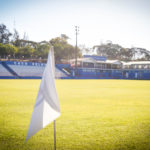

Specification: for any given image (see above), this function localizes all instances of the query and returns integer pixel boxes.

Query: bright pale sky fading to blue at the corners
[0,0,150,50]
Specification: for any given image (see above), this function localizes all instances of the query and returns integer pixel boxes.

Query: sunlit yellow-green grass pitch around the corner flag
[0,80,150,150]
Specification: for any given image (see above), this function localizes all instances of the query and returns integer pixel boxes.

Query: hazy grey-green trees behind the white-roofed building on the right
[93,42,150,61]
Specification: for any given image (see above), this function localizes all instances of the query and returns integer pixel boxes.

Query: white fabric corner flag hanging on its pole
[26,47,60,141]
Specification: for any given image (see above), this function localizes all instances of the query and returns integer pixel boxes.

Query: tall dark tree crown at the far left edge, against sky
[0,24,12,44]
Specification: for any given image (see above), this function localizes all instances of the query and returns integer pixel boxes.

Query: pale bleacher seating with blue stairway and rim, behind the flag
[0,61,67,79]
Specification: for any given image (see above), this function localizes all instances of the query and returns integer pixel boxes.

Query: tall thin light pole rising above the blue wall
[75,26,79,76]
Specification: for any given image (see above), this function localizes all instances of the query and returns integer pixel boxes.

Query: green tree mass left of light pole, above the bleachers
[0,24,81,63]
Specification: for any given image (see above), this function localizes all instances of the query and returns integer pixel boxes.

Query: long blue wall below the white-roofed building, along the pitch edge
[72,68,150,80]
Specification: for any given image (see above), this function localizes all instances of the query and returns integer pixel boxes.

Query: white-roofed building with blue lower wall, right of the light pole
[68,55,150,80]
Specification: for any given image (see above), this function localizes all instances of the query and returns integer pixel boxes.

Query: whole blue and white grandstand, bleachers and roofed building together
[0,55,150,80]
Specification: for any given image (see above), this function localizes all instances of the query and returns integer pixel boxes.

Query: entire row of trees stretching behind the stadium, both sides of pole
[0,24,150,63]
